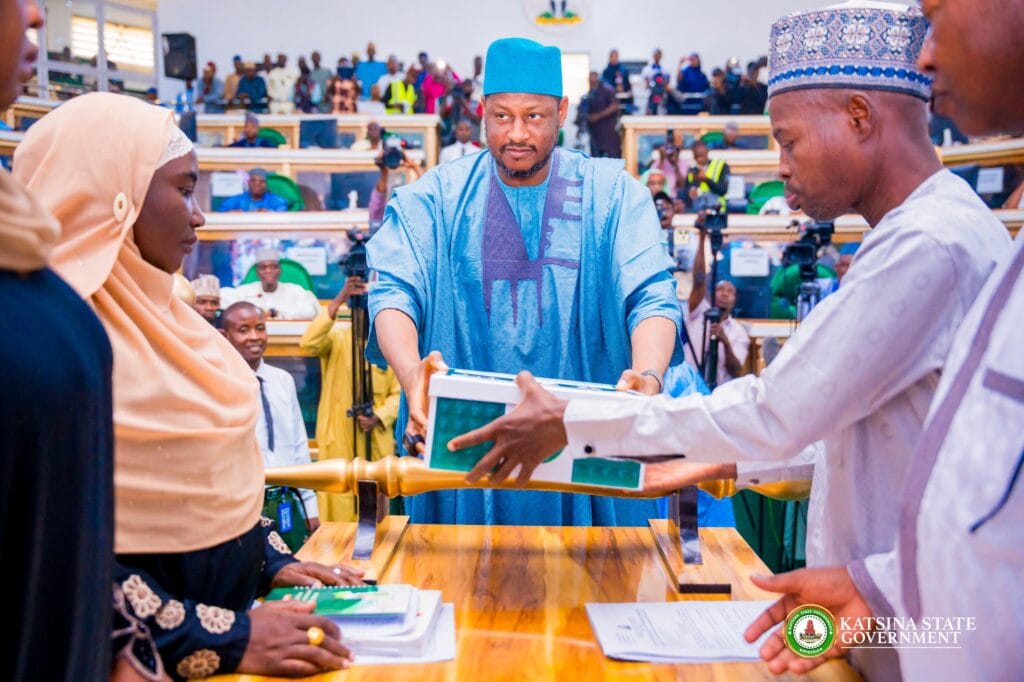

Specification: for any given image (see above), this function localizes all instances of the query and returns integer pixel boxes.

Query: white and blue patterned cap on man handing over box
[768,0,932,100]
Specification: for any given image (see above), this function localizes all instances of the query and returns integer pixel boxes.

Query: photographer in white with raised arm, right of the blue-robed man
[684,215,751,378]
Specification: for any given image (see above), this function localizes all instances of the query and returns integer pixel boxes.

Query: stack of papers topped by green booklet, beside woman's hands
[266,585,455,665]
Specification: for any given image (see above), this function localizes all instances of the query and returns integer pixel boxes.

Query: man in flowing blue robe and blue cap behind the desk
[367,39,681,525]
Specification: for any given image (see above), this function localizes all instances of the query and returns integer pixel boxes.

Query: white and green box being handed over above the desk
[424,370,643,491]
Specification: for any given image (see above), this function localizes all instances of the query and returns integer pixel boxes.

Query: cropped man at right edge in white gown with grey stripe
[746,0,1024,681]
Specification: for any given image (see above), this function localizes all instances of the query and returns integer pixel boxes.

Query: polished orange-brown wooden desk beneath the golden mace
[216,523,859,682]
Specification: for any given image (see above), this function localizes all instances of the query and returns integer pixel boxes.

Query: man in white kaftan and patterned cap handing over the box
[451,2,1010,673]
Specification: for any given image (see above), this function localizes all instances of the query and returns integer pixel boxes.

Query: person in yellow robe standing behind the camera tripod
[299,276,401,521]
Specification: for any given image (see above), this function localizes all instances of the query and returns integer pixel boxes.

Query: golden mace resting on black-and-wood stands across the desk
[266,456,731,594]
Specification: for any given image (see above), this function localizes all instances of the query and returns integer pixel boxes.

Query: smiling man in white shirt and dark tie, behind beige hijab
[220,302,319,543]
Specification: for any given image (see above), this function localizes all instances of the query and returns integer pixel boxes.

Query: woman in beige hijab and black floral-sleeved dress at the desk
[14,93,358,678]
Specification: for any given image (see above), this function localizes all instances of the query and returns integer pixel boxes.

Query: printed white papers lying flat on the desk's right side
[587,601,774,663]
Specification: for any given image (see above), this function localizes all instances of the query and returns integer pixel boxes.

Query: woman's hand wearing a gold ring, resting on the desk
[237,601,352,677]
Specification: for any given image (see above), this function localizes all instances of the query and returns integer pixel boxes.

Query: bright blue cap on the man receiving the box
[483,38,562,98]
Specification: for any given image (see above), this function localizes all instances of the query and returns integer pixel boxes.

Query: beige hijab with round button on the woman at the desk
[14,93,263,553]
